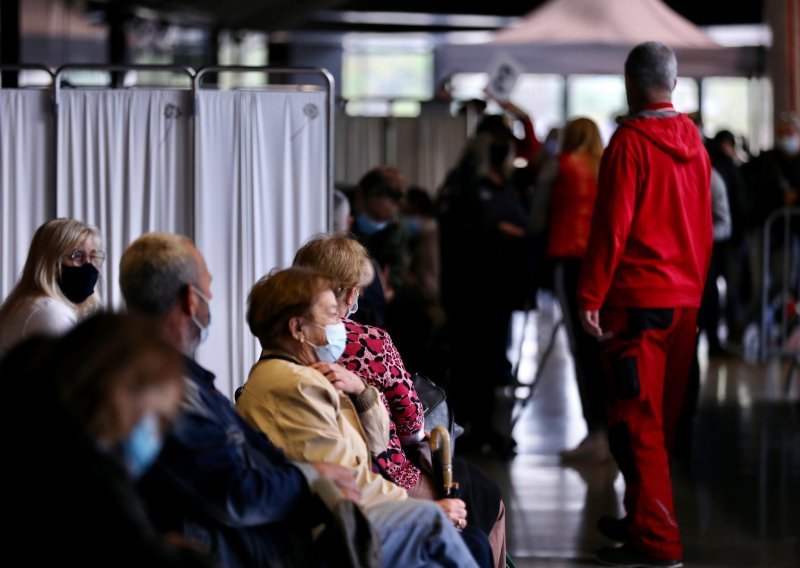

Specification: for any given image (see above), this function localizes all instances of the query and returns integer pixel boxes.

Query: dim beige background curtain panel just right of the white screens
[334,110,386,189]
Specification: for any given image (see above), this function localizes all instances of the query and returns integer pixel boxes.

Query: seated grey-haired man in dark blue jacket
[120,233,376,568]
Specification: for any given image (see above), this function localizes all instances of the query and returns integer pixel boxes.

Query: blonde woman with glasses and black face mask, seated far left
[0,219,105,356]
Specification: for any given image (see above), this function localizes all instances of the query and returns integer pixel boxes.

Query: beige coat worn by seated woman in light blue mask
[236,359,406,509]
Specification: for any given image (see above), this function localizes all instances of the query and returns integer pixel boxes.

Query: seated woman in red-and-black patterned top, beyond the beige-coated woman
[294,234,506,567]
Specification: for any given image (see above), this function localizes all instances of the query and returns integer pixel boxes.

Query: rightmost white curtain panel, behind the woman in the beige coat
[195,91,331,399]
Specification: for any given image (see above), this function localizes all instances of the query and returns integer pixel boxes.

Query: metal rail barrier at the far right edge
[759,207,800,362]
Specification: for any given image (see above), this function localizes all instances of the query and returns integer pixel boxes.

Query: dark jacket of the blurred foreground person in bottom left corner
[10,392,215,568]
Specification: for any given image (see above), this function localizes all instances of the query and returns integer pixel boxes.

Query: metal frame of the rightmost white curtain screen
[193,65,335,233]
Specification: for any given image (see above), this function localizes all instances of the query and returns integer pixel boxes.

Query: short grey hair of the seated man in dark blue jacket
[119,233,200,316]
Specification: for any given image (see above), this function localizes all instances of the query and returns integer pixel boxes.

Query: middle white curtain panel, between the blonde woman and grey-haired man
[56,89,192,309]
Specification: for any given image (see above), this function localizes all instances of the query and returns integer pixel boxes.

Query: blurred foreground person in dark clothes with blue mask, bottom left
[0,313,215,568]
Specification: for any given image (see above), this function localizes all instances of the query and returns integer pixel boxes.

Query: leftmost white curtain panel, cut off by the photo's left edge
[0,89,54,303]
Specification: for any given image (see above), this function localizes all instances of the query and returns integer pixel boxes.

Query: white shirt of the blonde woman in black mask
[0,296,78,357]
